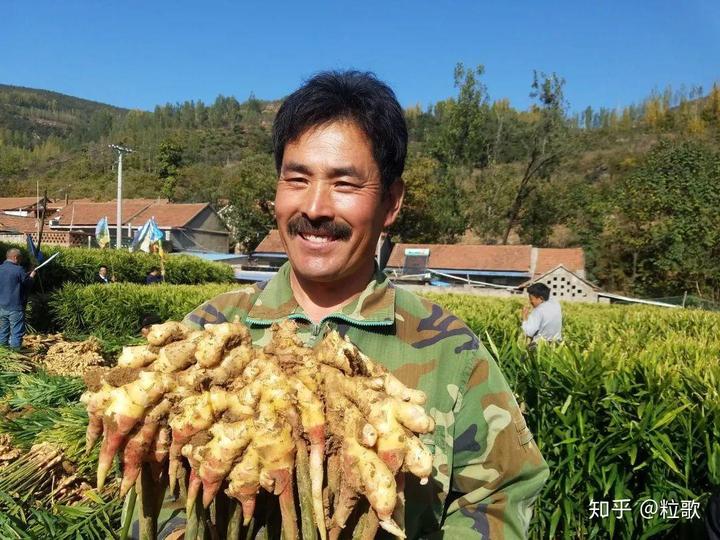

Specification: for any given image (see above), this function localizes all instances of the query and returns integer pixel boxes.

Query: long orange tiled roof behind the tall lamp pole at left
[54,199,208,228]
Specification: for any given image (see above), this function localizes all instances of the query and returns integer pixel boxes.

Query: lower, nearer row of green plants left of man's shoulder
[49,283,235,339]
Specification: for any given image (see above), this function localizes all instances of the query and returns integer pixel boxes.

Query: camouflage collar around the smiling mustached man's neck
[246,262,395,326]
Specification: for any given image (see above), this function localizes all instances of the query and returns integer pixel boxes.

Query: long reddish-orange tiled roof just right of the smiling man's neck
[387,244,532,272]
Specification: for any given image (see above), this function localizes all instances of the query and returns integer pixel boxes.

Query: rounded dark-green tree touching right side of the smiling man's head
[391,156,465,243]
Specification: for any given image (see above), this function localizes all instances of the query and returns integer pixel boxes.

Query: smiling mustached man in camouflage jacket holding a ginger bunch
[148,72,547,539]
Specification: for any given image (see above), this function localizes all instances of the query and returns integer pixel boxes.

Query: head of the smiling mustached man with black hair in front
[273,71,407,283]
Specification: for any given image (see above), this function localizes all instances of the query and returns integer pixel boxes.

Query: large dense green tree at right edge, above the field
[605,139,720,295]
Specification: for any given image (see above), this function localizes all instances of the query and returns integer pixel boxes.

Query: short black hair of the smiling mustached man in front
[273,71,408,189]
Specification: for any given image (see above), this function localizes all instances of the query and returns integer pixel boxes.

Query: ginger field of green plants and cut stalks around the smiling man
[0,292,720,539]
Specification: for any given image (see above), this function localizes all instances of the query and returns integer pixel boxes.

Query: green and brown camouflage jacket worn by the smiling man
[138,264,548,540]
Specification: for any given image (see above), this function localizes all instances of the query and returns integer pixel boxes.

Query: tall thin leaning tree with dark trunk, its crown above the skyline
[503,72,569,244]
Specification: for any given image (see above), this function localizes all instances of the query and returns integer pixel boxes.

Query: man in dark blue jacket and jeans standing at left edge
[0,248,36,349]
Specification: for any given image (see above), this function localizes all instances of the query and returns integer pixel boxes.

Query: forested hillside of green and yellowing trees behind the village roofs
[0,65,720,299]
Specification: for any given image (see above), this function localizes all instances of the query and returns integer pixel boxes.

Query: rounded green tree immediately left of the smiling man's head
[224,154,277,253]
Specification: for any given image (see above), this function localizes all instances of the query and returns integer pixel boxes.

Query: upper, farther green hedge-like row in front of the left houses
[0,242,234,292]
